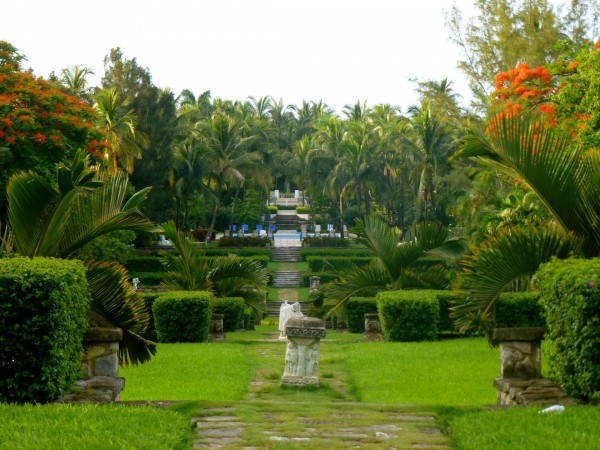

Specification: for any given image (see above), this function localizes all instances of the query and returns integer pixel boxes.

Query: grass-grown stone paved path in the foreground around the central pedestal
[192,342,450,450]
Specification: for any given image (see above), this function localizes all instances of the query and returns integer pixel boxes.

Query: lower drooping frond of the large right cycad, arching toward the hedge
[453,225,581,331]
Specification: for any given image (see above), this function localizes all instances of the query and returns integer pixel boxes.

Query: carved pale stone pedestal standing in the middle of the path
[281,317,326,386]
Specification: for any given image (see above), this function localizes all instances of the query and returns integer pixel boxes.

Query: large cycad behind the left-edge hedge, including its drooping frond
[3,152,156,364]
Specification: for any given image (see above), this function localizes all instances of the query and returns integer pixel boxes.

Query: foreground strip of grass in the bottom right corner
[449,406,600,450]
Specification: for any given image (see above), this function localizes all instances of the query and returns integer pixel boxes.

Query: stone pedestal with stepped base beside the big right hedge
[492,328,573,406]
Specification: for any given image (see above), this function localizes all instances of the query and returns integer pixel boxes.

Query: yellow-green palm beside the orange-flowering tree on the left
[94,87,148,174]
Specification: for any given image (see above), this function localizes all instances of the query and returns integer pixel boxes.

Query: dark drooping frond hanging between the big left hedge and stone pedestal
[85,261,156,366]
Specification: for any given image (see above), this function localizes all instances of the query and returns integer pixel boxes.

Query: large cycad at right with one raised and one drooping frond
[454,106,600,330]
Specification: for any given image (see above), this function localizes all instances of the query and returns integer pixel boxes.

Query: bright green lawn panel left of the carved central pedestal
[119,343,251,400]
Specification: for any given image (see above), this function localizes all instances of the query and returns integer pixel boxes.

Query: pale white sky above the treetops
[0,0,480,112]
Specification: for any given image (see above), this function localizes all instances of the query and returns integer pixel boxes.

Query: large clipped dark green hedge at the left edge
[0,257,90,403]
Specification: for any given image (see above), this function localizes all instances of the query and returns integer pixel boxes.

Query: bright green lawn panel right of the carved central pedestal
[340,338,500,406]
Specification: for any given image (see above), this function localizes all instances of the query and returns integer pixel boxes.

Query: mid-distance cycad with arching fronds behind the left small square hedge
[162,221,269,313]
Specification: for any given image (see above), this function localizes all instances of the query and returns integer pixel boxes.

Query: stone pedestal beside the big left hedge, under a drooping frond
[59,328,125,403]
